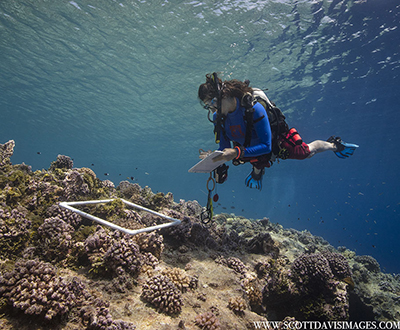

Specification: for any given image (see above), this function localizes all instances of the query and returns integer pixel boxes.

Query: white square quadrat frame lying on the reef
[59,198,181,235]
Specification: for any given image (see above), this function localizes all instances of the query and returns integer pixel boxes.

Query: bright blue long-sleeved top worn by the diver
[214,99,272,157]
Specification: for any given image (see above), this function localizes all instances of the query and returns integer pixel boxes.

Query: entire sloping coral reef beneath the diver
[0,141,400,329]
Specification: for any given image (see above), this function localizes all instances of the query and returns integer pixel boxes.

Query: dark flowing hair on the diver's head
[198,73,253,101]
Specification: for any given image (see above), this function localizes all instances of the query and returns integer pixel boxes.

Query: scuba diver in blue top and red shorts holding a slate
[198,72,358,190]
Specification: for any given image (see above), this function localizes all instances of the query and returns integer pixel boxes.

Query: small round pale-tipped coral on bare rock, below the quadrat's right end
[141,275,183,314]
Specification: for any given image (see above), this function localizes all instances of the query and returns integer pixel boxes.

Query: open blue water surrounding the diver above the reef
[0,0,400,273]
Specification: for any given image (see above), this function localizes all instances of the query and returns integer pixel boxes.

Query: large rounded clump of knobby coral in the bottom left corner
[0,260,80,320]
